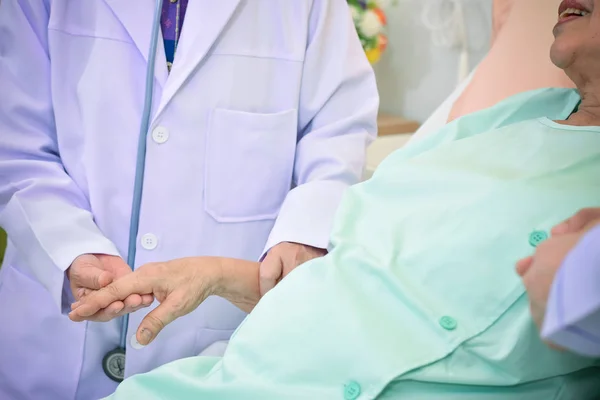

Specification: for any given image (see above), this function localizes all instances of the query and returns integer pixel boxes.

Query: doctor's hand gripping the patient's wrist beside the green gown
[260,242,327,296]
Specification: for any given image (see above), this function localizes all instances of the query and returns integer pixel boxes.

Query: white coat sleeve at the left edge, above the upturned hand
[0,0,118,312]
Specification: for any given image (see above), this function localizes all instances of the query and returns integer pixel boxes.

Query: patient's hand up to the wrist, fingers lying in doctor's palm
[69,257,222,345]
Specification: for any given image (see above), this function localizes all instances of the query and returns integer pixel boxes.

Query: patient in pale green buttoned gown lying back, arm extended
[71,0,600,400]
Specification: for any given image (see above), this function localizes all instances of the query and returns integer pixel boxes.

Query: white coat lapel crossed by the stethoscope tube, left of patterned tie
[104,0,169,87]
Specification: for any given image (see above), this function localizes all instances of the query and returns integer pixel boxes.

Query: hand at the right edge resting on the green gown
[517,209,600,340]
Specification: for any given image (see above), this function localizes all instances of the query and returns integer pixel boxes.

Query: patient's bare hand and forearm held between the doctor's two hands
[69,257,260,345]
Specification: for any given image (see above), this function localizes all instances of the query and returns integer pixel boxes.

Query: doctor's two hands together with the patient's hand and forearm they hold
[67,242,326,345]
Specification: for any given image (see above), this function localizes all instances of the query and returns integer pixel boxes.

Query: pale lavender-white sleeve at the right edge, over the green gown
[542,226,600,357]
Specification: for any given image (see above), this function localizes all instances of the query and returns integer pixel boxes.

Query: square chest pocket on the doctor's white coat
[204,109,298,222]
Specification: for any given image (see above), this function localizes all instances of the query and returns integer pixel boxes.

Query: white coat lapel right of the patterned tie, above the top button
[156,0,240,116]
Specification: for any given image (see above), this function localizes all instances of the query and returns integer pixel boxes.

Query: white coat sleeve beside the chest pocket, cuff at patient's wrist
[263,0,379,257]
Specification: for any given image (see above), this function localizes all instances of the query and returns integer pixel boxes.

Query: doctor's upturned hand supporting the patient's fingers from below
[67,254,154,321]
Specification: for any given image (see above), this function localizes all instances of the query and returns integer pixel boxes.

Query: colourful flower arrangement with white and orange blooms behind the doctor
[348,0,390,64]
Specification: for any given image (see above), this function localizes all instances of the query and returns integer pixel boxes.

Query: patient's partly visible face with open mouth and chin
[550,0,600,73]
